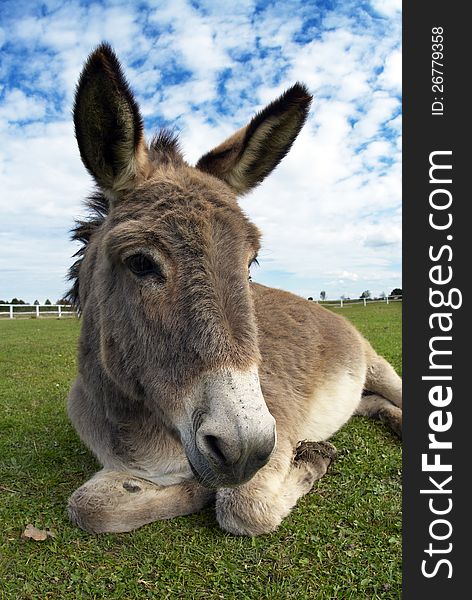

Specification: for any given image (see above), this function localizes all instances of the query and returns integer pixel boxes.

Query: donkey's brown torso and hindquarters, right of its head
[254,284,401,442]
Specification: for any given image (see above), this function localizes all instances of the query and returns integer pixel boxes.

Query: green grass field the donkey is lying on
[0,303,401,600]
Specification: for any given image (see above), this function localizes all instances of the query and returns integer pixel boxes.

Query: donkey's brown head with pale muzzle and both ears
[74,44,311,486]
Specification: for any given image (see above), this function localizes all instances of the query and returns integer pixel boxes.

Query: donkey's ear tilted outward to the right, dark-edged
[196,83,312,194]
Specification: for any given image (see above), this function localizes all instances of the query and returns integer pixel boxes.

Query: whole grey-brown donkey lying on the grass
[68,44,402,536]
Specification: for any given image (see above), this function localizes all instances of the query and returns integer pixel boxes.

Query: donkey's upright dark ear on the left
[74,43,148,193]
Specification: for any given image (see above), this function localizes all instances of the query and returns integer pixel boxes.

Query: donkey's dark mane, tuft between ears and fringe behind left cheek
[66,129,183,312]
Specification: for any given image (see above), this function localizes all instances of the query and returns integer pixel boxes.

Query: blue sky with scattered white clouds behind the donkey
[0,0,401,302]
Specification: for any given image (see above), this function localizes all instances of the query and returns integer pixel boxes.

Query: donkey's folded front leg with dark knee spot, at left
[67,469,214,533]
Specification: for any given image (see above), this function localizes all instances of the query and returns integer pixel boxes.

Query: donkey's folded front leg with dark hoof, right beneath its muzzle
[216,440,336,536]
